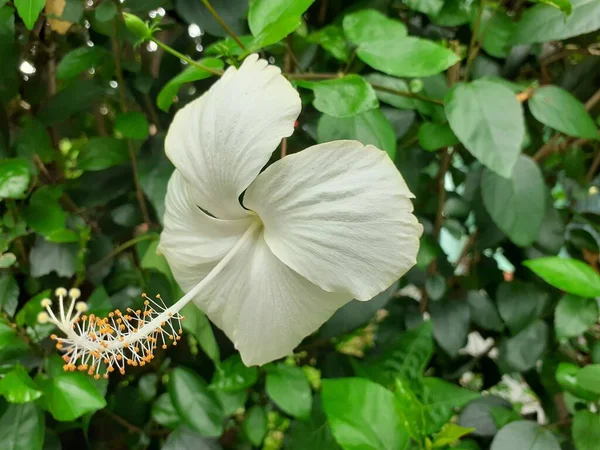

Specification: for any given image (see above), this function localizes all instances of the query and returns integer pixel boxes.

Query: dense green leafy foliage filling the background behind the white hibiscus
[0,0,600,450]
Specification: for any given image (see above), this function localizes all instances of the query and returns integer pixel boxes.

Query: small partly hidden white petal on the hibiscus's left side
[159,170,251,291]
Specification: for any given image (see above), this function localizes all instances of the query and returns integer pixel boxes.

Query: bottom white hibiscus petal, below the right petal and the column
[194,230,352,365]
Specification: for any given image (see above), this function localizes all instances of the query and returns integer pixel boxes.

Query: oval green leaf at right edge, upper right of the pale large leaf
[529,85,600,139]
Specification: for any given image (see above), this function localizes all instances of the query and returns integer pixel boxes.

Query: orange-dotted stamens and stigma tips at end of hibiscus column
[38,288,184,379]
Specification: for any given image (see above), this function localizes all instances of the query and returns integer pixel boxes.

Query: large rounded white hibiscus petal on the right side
[244,141,423,300]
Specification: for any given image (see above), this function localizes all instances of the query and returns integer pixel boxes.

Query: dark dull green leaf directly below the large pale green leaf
[481,155,546,247]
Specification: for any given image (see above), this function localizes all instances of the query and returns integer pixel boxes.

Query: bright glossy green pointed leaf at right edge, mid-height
[523,256,600,298]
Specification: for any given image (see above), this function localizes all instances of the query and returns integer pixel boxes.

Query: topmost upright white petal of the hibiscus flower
[165,55,301,219]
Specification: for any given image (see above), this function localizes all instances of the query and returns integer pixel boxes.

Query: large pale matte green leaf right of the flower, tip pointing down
[445,80,525,178]
